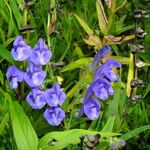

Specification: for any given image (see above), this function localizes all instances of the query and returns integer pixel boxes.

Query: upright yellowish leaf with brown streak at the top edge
[96,0,107,33]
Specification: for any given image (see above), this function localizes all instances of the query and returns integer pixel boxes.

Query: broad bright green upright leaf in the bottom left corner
[9,97,38,150]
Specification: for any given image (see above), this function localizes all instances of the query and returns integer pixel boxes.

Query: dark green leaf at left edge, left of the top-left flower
[0,44,16,65]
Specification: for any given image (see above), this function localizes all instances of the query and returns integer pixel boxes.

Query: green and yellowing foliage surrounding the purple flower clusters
[0,0,150,150]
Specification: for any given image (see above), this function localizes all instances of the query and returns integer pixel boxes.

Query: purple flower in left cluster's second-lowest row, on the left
[26,88,46,109]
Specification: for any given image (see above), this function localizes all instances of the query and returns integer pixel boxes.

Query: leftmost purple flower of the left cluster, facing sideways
[6,66,24,89]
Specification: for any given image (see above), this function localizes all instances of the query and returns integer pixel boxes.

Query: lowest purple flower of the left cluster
[44,107,65,126]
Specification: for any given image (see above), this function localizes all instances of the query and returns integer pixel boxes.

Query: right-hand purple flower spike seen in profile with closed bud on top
[79,46,121,120]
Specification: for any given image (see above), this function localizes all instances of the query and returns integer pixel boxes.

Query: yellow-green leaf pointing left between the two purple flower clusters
[61,57,93,72]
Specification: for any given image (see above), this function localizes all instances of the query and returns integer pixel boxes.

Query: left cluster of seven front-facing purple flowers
[6,36,66,126]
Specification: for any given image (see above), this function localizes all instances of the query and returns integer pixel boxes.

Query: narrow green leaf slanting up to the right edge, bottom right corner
[121,125,150,140]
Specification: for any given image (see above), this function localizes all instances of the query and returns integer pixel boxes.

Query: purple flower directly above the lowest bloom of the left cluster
[45,83,66,106]
